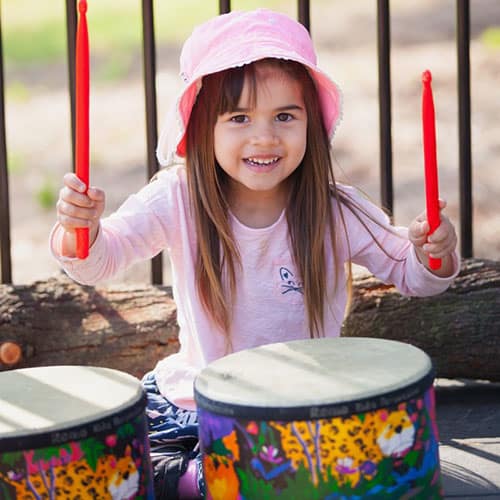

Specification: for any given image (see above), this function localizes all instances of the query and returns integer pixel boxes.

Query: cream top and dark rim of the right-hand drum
[195,338,433,420]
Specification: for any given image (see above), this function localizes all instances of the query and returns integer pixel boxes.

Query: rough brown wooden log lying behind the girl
[0,259,500,381]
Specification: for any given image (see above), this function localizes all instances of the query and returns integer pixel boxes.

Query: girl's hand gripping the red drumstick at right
[408,200,457,276]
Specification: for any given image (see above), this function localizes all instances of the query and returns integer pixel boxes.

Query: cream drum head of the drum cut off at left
[0,366,145,443]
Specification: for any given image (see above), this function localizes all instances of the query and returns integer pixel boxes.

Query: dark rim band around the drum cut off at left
[0,390,147,453]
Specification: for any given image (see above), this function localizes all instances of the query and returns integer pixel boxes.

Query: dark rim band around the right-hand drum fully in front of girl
[194,366,436,421]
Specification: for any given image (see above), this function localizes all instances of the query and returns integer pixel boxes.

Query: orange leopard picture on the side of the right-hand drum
[270,408,415,486]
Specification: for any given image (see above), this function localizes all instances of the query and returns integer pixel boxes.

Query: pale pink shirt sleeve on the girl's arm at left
[49,167,183,285]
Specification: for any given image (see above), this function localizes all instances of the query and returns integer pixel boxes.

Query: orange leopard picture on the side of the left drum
[0,455,139,500]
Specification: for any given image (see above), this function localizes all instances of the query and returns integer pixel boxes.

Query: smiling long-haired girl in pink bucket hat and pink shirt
[51,9,459,498]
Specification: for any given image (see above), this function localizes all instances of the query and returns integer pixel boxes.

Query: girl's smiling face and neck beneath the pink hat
[214,63,307,219]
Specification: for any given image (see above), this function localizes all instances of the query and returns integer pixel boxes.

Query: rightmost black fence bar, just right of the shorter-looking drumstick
[457,0,473,257]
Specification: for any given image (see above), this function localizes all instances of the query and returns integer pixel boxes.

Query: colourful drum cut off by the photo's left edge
[0,366,154,500]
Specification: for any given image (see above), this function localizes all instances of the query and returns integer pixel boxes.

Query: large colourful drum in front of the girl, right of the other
[195,338,442,500]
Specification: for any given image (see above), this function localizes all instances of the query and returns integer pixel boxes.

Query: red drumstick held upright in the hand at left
[75,0,90,259]
